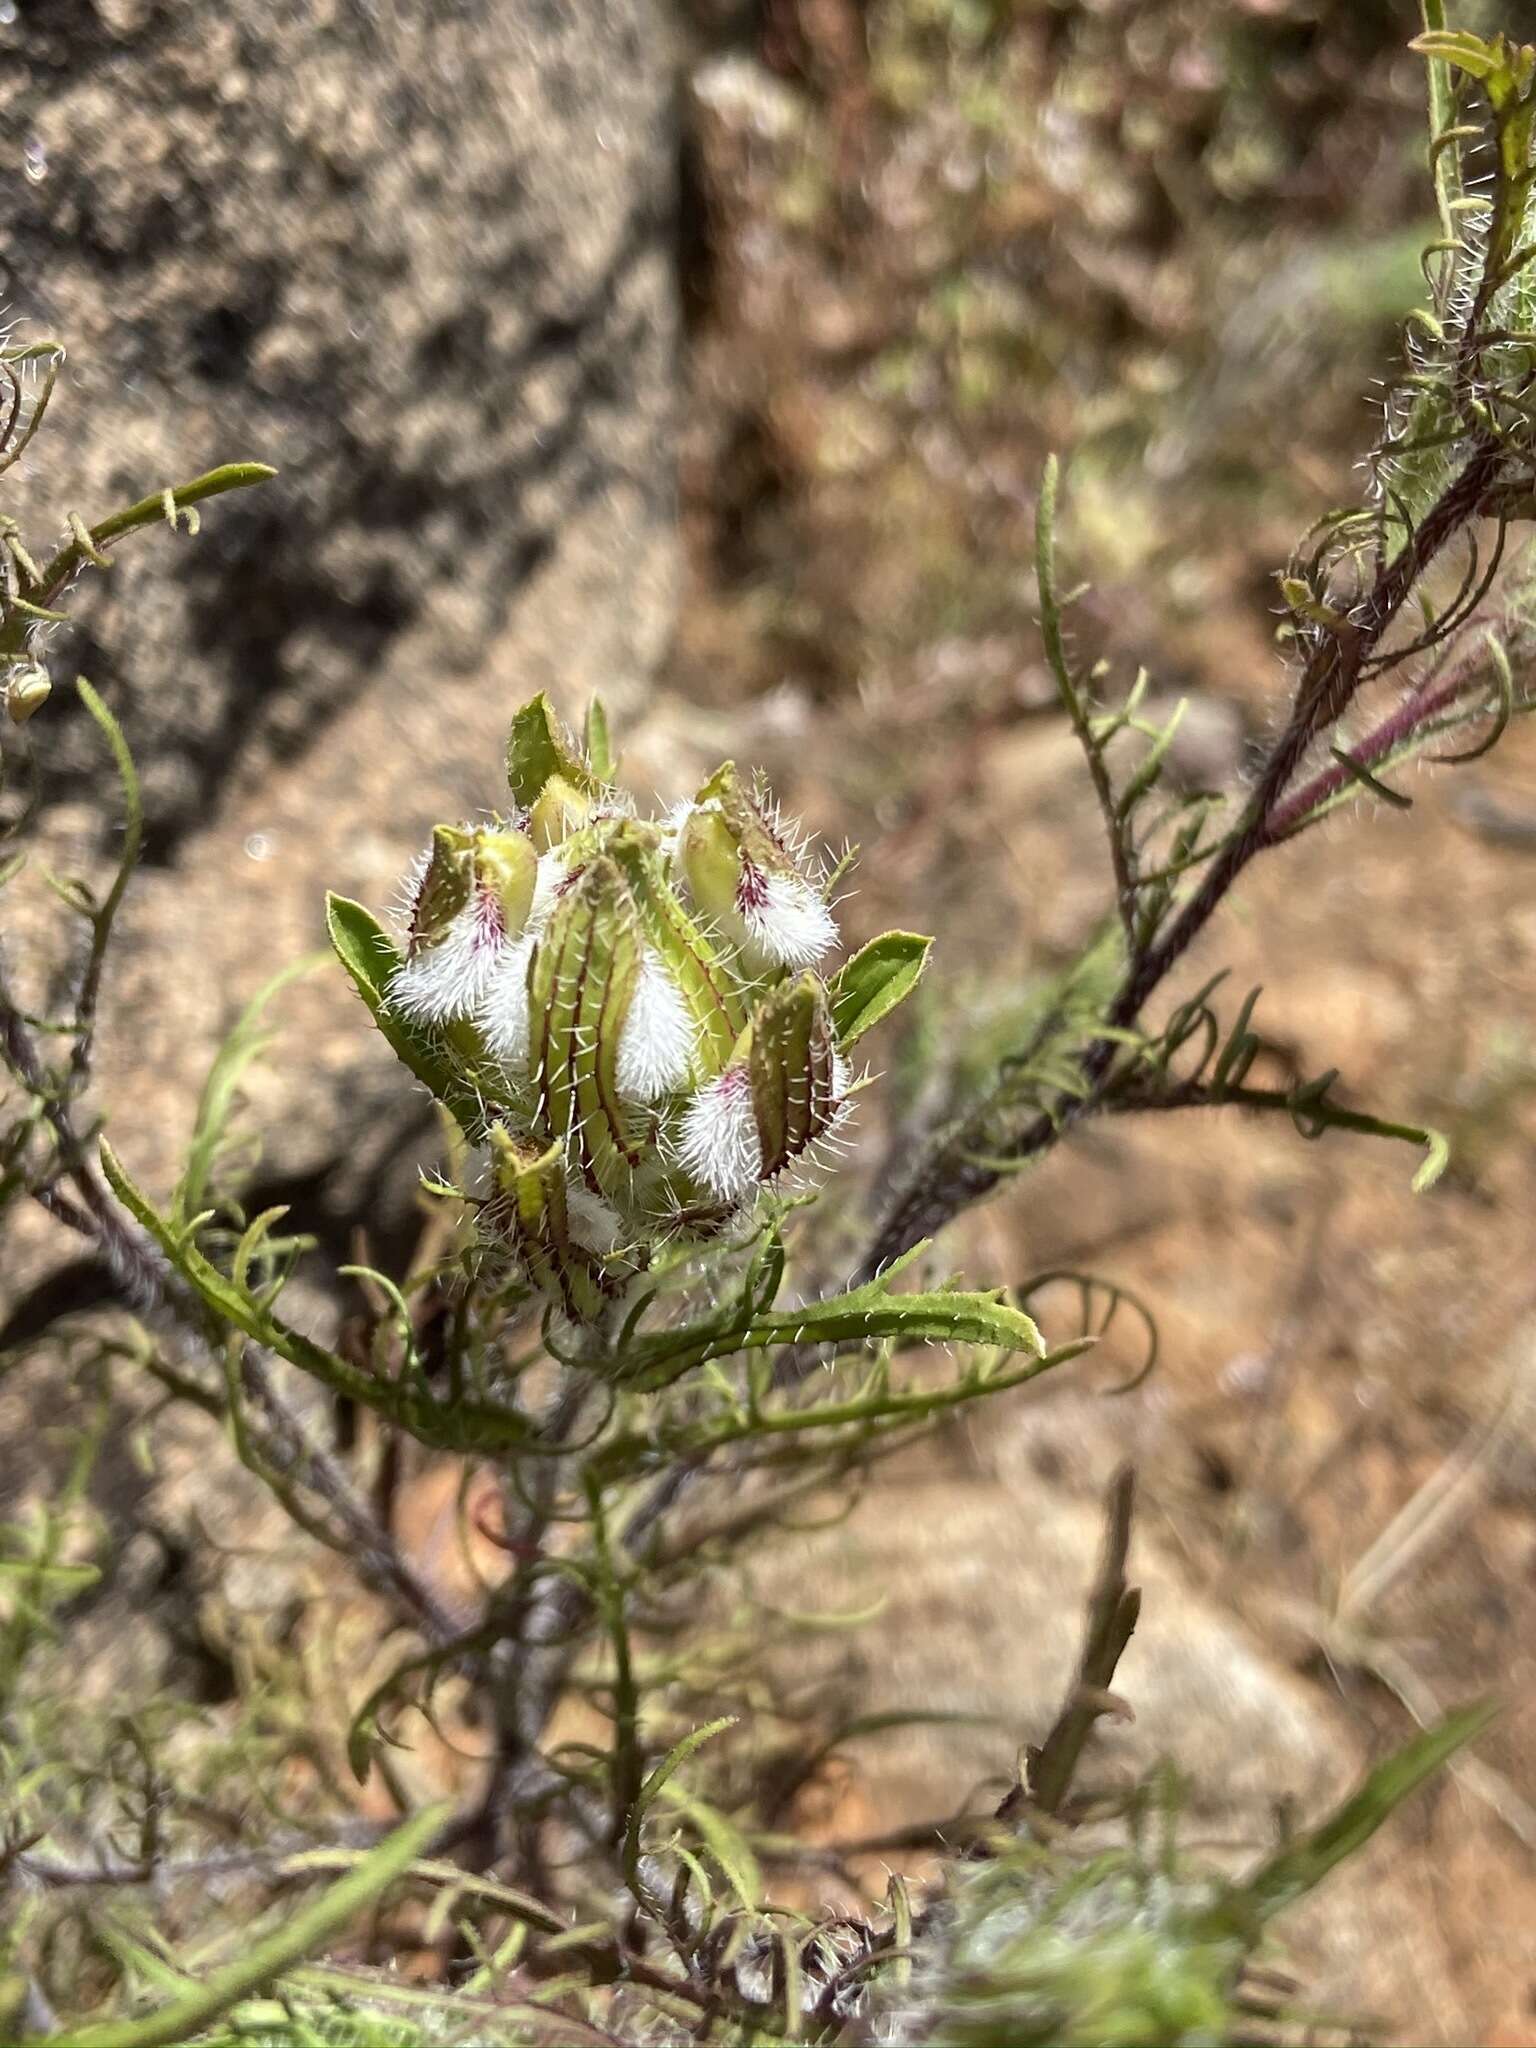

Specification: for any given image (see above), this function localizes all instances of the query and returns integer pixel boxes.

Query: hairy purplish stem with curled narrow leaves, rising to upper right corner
[866,6,1536,1270]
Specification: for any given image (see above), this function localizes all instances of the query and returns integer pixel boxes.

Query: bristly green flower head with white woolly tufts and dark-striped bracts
[332,696,928,1323]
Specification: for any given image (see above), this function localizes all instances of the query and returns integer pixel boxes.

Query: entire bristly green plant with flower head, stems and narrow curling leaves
[0,0,1536,2048]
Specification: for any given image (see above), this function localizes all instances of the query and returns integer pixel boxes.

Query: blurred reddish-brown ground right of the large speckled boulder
[639,0,1536,2042]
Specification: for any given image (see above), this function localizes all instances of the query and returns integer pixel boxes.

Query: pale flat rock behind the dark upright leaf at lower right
[772,1470,1352,1826]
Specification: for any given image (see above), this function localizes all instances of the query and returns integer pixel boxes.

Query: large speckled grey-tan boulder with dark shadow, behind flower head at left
[0,0,676,1277]
